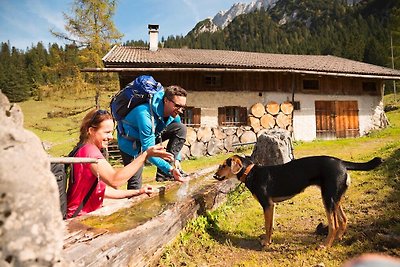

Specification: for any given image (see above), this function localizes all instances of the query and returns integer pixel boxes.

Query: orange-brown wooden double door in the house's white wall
[315,101,359,139]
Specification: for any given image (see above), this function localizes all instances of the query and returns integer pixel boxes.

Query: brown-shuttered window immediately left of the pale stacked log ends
[218,106,247,126]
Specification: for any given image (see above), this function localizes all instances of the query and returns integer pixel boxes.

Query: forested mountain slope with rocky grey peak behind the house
[163,0,400,69]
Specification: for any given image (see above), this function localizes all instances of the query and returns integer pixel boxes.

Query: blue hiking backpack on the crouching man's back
[110,75,164,136]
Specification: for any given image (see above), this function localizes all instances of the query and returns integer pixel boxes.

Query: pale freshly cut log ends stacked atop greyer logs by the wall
[248,101,293,133]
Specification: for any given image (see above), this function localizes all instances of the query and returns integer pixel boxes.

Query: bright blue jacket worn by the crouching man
[117,91,181,173]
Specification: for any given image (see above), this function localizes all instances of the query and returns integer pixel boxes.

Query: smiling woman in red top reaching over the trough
[67,110,173,218]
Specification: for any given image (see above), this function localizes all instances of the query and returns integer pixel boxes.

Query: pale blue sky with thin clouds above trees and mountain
[0,0,251,50]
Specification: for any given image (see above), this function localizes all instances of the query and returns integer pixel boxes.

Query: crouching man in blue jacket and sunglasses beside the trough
[118,85,188,189]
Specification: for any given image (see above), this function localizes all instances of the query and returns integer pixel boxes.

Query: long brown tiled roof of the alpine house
[99,46,400,80]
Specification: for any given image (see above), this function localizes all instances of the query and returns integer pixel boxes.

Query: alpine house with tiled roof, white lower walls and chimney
[92,26,400,141]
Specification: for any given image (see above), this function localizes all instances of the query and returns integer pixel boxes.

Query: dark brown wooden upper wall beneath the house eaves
[120,71,383,95]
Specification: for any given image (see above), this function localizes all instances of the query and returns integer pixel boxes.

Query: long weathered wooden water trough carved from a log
[63,166,238,267]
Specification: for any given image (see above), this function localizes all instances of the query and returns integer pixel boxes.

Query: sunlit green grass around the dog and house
[19,92,400,266]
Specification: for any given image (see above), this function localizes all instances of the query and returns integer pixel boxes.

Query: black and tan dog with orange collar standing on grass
[214,155,382,248]
